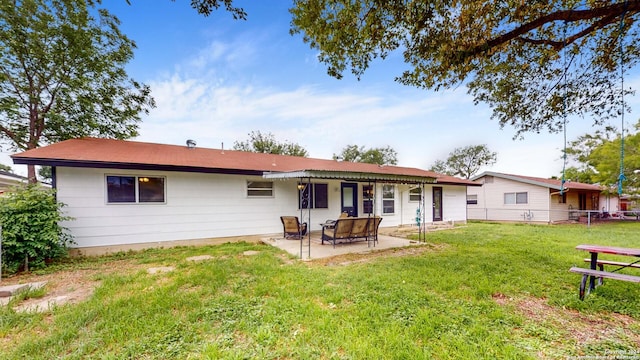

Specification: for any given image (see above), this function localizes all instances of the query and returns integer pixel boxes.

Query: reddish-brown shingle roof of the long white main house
[11,138,476,185]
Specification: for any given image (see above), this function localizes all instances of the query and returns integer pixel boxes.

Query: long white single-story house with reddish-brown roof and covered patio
[12,138,478,254]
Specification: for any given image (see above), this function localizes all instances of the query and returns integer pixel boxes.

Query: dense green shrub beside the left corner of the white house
[0,185,73,273]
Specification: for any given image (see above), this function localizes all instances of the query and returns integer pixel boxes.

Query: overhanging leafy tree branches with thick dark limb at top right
[291,0,640,137]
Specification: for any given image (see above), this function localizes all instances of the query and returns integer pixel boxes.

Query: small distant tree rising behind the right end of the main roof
[431,144,498,179]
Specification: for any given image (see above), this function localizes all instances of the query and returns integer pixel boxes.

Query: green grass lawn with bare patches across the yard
[0,222,640,359]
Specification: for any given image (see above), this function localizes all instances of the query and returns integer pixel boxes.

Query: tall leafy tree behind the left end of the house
[0,0,155,181]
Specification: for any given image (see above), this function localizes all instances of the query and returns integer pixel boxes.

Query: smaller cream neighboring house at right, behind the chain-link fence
[467,172,619,223]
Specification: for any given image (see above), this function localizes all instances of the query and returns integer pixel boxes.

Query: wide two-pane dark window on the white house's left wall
[107,175,165,204]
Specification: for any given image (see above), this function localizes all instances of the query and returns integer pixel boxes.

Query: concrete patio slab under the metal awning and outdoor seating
[262,231,420,260]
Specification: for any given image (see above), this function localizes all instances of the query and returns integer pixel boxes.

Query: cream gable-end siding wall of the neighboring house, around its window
[467,177,549,222]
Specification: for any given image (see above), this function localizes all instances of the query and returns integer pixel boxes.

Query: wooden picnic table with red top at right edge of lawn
[569,244,640,300]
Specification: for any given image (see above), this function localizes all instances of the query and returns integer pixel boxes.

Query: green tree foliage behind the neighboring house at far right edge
[565,122,640,193]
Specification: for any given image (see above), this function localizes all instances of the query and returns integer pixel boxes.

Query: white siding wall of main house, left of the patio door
[56,167,340,248]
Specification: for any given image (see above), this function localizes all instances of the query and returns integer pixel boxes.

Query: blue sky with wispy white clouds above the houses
[6,0,639,177]
